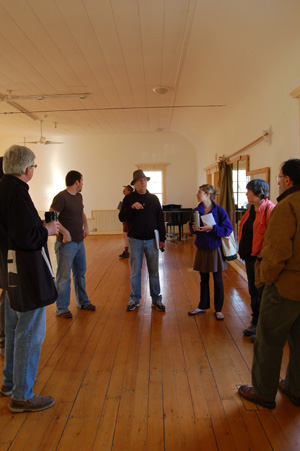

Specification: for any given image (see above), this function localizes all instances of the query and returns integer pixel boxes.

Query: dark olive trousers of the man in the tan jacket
[252,285,300,401]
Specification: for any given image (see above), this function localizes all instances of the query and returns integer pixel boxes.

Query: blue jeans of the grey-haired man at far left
[3,296,46,401]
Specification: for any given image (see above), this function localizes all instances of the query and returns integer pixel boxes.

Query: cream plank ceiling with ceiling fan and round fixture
[0,0,300,138]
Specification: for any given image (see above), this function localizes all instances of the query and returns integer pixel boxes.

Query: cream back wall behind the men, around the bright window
[0,133,198,216]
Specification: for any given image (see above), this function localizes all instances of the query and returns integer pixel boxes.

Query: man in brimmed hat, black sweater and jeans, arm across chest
[119,169,166,312]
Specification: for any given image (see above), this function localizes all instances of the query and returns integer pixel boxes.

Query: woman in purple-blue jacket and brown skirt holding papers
[188,184,233,321]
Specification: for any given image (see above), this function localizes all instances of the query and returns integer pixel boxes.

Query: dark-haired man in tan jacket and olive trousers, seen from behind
[239,159,300,409]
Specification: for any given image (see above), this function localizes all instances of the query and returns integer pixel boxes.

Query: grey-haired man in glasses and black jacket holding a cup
[0,145,59,412]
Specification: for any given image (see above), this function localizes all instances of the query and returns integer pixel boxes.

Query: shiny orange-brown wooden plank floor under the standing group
[0,236,300,451]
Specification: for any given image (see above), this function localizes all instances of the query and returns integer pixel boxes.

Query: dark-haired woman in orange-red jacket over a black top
[238,179,275,342]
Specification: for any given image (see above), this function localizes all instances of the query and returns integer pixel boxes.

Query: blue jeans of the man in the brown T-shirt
[55,241,90,315]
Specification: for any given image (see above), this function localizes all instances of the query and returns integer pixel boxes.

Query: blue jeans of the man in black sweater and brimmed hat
[129,237,162,303]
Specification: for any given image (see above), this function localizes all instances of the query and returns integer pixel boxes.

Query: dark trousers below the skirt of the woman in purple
[198,271,224,312]
